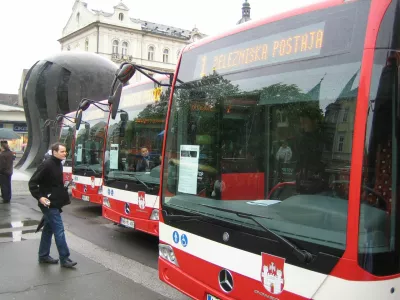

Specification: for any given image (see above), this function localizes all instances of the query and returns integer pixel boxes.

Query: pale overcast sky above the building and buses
[0,0,324,94]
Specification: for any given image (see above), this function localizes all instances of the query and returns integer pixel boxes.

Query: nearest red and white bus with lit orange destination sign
[155,0,400,300]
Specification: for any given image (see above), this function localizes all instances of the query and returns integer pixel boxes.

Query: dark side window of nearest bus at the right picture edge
[359,50,400,276]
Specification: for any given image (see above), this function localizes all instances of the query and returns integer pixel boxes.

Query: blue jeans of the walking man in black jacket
[39,207,69,263]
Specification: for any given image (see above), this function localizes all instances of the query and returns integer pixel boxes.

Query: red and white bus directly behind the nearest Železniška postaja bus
[103,76,169,236]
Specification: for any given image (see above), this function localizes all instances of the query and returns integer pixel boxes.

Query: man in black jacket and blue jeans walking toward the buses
[29,143,76,268]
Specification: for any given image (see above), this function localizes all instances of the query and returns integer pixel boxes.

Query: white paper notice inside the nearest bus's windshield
[178,145,200,195]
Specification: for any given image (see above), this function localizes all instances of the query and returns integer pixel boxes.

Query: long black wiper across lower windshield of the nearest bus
[198,203,313,263]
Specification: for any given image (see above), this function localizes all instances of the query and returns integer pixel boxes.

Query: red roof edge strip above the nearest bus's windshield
[182,0,346,53]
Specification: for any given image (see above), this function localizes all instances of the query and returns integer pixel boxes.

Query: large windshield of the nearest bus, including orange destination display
[162,3,378,252]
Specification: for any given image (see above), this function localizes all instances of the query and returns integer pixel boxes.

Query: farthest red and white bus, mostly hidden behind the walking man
[59,111,76,185]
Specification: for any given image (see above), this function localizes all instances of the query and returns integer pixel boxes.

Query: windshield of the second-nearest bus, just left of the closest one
[104,82,168,195]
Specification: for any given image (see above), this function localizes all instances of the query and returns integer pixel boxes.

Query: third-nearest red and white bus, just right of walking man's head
[72,100,109,204]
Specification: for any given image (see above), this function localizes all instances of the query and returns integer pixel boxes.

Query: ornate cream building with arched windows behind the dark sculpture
[59,0,205,80]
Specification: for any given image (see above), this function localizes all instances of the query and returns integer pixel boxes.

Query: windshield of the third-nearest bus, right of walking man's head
[73,107,108,177]
